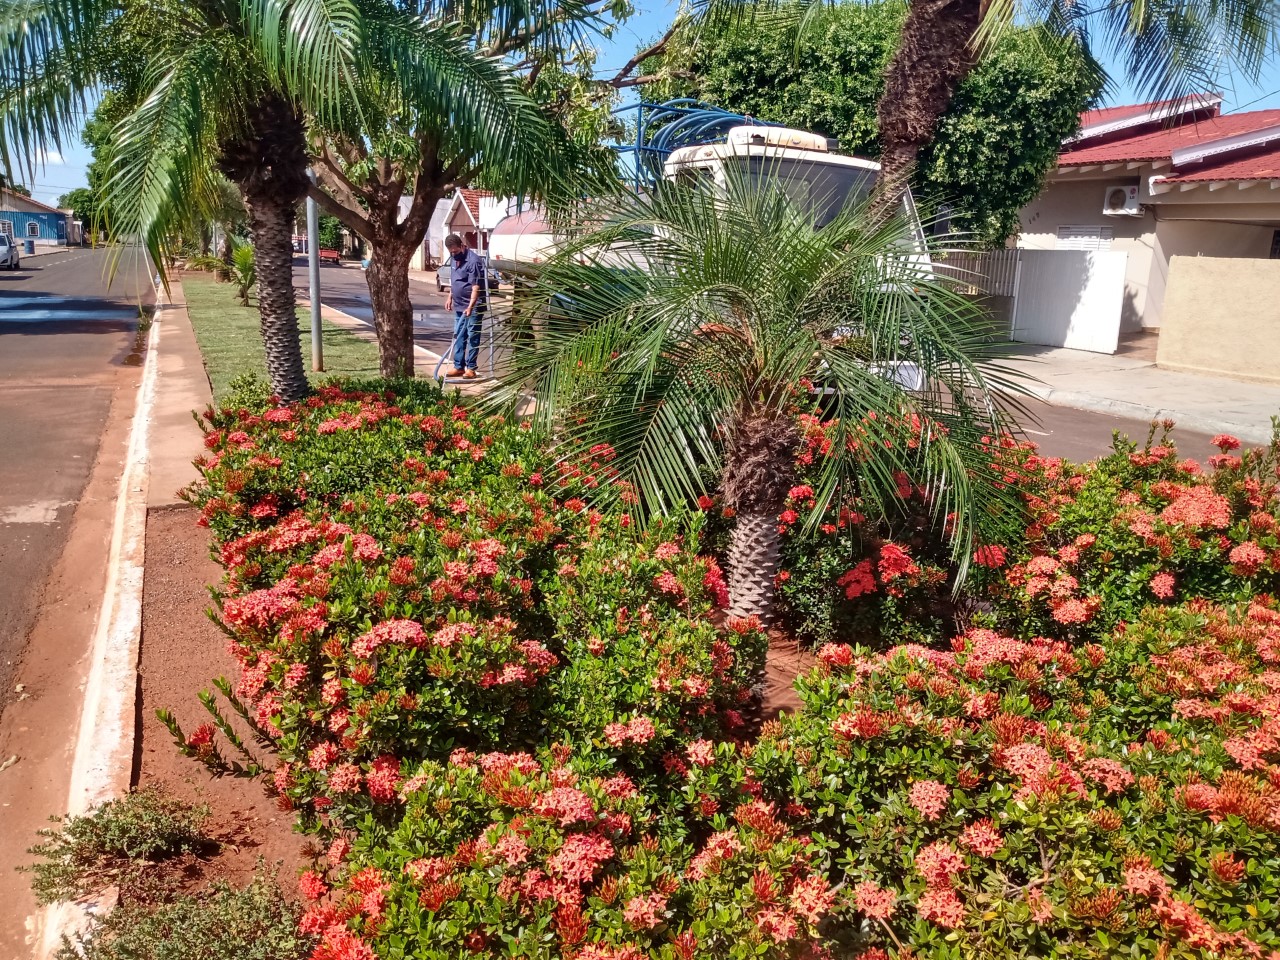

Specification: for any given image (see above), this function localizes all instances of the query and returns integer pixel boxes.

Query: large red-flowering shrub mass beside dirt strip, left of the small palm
[184,388,763,820]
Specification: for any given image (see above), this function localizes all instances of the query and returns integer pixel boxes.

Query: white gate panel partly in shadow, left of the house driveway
[1011,248,1129,353]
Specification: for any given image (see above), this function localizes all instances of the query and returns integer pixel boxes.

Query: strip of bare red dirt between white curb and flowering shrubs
[134,506,311,895]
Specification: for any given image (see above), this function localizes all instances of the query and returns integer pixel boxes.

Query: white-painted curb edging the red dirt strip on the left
[37,297,161,960]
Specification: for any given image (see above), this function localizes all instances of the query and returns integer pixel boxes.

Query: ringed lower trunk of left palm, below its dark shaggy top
[246,188,307,403]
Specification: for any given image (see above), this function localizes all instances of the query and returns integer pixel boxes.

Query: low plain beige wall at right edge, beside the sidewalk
[1156,256,1280,383]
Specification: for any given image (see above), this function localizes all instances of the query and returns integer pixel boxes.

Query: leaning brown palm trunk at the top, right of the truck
[872,0,987,215]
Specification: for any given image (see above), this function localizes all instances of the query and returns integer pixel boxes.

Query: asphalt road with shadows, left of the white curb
[0,248,154,709]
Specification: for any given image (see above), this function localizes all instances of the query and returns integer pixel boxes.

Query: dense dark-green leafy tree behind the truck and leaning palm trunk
[641,0,1100,244]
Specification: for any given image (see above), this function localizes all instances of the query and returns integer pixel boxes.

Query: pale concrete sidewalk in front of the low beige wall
[1004,344,1280,444]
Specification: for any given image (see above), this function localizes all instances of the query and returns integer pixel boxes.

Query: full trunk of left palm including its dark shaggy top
[218,95,307,403]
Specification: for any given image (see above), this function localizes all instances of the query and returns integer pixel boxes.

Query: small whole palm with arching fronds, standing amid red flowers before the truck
[502,167,1016,621]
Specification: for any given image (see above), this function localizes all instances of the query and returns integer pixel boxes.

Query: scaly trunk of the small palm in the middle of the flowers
[723,411,800,626]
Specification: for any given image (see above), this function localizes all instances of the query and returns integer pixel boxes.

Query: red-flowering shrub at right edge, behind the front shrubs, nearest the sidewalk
[974,422,1280,640]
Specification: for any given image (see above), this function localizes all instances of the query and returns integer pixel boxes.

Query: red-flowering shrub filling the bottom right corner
[750,602,1280,957]
